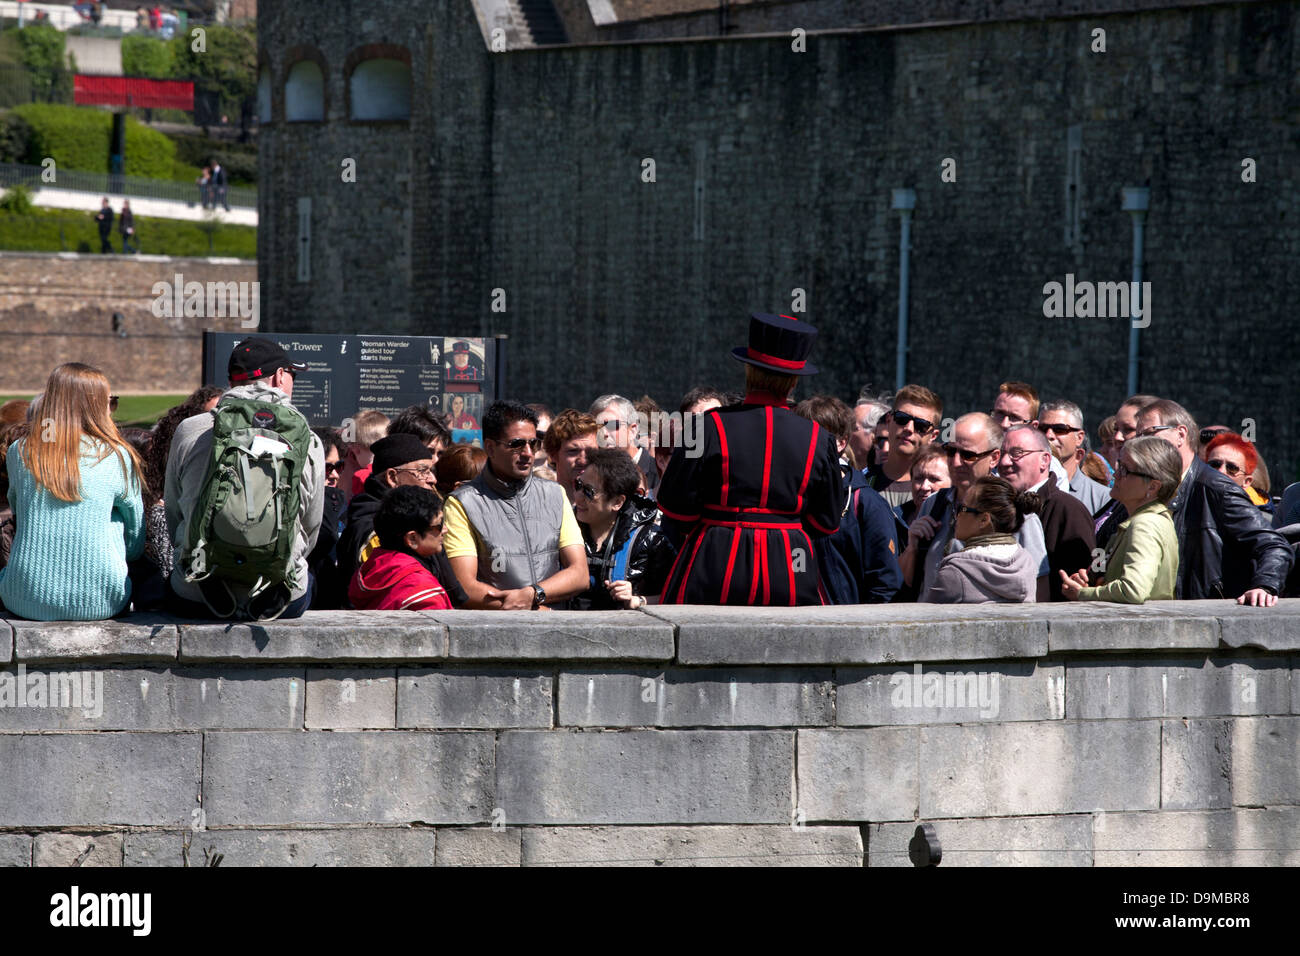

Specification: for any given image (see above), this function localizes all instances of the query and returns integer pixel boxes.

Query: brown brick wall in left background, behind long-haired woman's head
[0,252,257,393]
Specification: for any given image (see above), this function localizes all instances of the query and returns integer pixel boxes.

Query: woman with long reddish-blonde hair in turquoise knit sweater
[0,363,144,620]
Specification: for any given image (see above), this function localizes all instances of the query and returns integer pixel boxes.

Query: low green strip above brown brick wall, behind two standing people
[0,202,257,259]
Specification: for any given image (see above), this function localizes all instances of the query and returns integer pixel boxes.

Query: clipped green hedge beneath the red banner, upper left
[9,103,176,179]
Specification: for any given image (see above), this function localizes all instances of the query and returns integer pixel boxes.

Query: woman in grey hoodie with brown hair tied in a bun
[920,476,1039,604]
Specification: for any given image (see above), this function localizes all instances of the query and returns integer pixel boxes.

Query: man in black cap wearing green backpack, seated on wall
[164,336,325,620]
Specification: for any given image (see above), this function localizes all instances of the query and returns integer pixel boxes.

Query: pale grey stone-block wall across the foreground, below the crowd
[0,601,1300,866]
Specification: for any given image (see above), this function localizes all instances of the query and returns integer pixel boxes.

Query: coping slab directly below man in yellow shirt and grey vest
[441,611,673,661]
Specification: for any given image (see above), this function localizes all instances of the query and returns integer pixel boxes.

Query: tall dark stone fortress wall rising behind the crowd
[259,0,1300,483]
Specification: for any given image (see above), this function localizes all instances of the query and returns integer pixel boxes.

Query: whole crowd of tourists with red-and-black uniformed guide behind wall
[0,321,1300,620]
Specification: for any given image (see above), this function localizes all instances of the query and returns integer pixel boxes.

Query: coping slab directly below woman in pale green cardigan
[1048,601,1222,654]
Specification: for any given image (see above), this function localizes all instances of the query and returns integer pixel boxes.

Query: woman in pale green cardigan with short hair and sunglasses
[1058,436,1183,604]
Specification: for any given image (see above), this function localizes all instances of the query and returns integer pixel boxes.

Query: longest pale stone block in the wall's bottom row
[524,826,862,866]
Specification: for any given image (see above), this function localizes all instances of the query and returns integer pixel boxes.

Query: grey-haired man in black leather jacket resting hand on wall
[1097,399,1295,607]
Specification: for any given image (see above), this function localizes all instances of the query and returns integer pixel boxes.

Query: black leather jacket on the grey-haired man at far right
[1097,459,1295,600]
